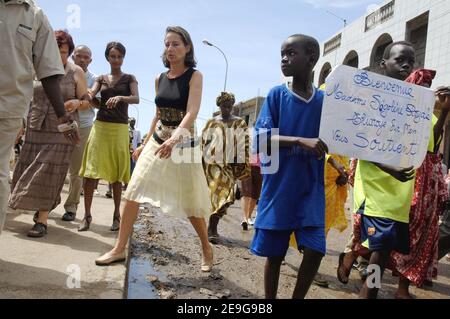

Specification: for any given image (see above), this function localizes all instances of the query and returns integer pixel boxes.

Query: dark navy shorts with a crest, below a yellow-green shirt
[361,215,410,255]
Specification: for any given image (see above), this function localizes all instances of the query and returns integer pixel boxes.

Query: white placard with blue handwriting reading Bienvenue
[320,65,435,168]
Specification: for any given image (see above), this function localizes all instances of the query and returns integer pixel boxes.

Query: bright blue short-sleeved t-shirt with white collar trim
[253,85,325,230]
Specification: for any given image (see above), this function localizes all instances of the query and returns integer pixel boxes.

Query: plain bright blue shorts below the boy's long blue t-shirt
[250,227,326,257]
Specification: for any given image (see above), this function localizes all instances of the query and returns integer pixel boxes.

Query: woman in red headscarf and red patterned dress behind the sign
[391,69,450,299]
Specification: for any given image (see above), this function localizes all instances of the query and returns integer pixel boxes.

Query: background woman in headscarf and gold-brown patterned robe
[202,92,250,244]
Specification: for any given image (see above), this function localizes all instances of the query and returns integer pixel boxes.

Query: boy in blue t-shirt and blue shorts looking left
[251,34,328,299]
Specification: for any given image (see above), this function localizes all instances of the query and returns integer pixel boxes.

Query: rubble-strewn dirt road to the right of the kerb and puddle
[129,201,450,299]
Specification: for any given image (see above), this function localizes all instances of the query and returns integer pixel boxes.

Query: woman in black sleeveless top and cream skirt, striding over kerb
[96,27,213,272]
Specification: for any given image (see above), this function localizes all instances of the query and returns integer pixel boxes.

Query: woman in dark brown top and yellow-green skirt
[78,42,139,231]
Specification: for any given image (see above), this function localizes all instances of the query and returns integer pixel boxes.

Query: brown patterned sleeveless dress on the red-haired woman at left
[9,63,78,211]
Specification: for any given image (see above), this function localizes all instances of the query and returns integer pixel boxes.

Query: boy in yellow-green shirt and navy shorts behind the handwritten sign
[337,41,415,299]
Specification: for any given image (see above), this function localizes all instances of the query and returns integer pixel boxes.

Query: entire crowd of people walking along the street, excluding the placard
[0,0,450,298]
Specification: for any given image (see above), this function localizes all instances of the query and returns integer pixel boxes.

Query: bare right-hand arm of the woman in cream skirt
[155,71,203,158]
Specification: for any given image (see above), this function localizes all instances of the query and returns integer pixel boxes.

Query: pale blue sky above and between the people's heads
[36,0,382,134]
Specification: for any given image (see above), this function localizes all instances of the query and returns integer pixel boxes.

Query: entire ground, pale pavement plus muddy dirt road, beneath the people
[0,184,450,299]
